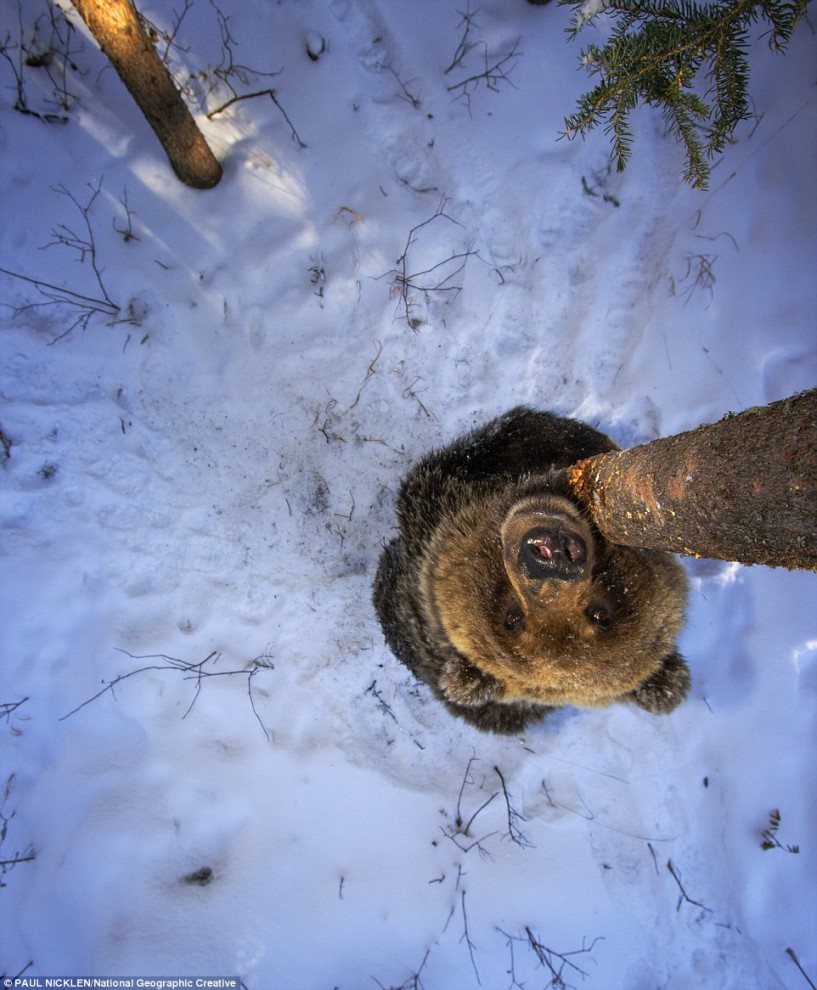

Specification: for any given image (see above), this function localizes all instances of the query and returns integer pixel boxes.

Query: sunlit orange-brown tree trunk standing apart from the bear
[72,0,221,189]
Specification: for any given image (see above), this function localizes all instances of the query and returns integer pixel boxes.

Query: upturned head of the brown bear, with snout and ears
[419,478,688,711]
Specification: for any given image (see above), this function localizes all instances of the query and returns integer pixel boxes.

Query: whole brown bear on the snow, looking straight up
[374,406,689,733]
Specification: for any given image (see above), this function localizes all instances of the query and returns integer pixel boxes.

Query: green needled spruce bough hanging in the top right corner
[561,0,808,189]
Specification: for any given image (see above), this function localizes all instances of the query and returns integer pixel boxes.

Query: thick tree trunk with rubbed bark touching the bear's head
[570,389,817,570]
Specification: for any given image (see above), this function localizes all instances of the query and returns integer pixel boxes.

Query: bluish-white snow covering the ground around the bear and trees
[0,0,817,990]
